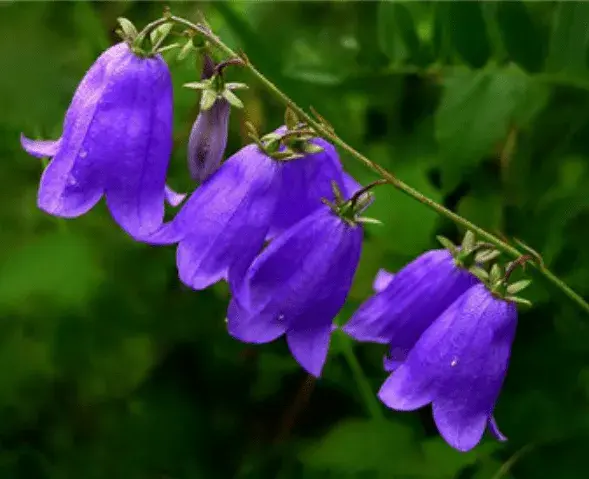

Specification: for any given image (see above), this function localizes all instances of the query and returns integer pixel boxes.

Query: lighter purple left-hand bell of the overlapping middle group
[173,145,282,289]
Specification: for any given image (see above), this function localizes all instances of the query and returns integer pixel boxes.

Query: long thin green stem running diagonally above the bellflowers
[168,15,589,313]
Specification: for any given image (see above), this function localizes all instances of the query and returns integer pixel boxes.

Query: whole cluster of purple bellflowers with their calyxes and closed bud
[21,23,525,451]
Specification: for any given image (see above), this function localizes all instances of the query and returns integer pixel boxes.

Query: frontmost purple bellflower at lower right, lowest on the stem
[379,284,517,451]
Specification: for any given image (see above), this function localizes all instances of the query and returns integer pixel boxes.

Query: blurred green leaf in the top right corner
[546,2,589,74]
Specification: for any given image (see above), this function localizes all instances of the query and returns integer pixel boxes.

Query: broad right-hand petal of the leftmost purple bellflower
[105,51,172,237]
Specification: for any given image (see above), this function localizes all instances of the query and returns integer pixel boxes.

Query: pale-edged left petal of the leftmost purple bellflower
[34,43,132,217]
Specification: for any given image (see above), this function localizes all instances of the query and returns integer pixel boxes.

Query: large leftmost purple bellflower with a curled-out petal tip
[21,42,172,236]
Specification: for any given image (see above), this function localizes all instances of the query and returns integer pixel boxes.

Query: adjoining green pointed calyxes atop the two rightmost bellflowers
[437,231,532,306]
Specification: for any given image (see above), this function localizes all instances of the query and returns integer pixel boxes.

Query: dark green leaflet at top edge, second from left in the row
[446,2,491,67]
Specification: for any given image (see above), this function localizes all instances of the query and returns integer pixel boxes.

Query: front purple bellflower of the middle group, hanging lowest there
[227,206,362,376]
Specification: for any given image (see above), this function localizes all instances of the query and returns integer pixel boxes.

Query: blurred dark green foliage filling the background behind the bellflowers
[0,1,589,479]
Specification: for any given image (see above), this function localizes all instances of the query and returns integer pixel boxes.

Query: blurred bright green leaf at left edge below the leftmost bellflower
[0,233,102,311]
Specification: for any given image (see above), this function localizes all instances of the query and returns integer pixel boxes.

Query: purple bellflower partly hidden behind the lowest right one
[343,249,478,370]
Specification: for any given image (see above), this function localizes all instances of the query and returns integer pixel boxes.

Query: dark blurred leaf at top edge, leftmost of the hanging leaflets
[377,0,420,65]
